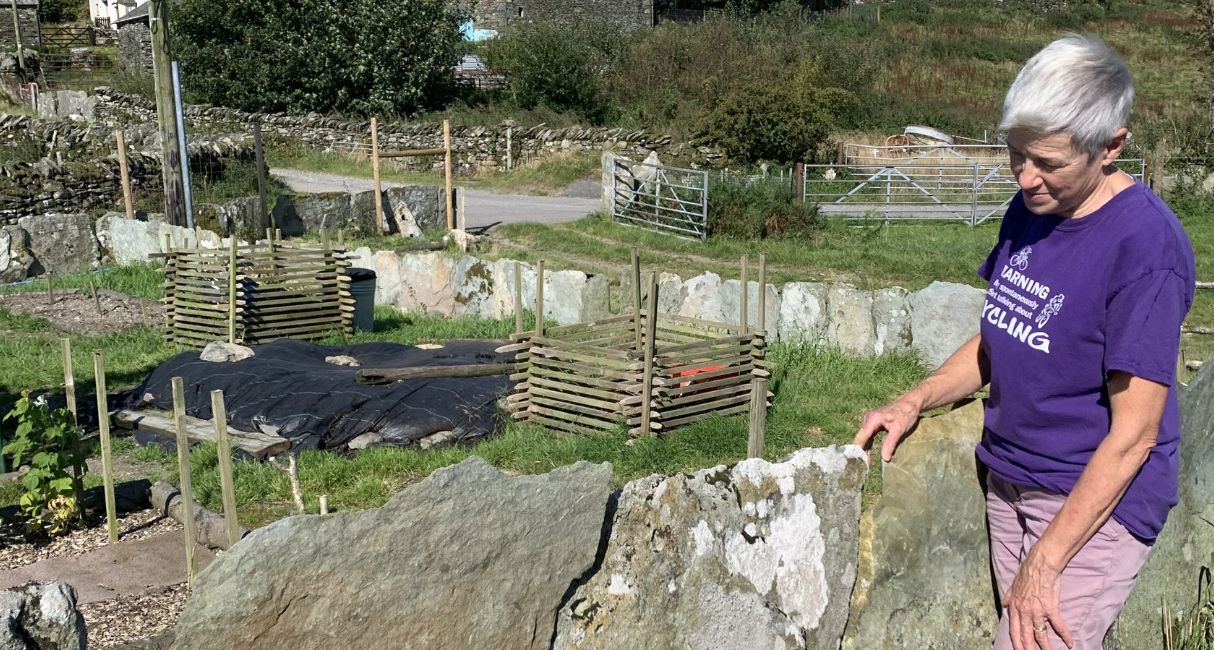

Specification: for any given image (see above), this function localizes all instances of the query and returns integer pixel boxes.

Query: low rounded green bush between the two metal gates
[708,177,822,239]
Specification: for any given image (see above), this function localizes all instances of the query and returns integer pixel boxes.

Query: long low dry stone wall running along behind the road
[97,89,724,173]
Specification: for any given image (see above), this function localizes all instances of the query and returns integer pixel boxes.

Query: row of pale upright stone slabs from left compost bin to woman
[351,248,985,366]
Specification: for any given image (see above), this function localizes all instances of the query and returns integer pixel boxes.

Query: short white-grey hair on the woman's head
[999,34,1134,157]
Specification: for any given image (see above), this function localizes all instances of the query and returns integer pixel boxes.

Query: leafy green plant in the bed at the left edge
[4,390,85,535]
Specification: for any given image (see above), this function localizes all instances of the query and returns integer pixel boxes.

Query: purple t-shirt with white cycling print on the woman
[977,185,1196,543]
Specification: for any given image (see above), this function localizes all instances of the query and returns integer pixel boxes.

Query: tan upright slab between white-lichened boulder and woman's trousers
[843,401,999,650]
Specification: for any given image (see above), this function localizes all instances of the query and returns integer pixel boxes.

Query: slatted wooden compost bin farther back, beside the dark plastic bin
[164,239,354,345]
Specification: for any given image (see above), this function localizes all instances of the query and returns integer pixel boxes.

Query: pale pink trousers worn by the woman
[987,474,1151,650]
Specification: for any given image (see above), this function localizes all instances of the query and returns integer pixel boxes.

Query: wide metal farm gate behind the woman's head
[801,145,1146,226]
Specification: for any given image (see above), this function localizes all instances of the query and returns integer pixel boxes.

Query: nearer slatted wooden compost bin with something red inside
[507,255,770,442]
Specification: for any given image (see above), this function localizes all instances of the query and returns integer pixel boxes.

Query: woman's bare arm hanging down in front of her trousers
[1003,372,1168,650]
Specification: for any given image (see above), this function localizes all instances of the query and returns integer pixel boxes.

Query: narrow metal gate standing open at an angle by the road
[611,158,708,239]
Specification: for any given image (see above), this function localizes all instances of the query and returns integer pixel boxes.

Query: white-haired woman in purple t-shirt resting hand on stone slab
[855,35,1195,650]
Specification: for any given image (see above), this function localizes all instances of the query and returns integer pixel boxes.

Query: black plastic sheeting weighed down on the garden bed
[127,340,512,450]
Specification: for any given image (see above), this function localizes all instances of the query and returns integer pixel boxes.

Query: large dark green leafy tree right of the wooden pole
[169,0,460,114]
